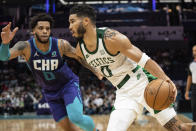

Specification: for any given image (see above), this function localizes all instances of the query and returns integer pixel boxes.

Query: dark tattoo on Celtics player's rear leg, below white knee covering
[164,118,185,131]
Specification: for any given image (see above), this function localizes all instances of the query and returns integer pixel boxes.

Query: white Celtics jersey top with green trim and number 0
[79,28,137,86]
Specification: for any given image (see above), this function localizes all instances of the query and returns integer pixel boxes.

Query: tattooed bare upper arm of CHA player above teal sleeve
[9,41,27,60]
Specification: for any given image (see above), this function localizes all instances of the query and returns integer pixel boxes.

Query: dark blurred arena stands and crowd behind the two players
[0,0,196,115]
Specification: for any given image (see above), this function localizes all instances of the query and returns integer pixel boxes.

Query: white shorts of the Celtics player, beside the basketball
[114,68,176,125]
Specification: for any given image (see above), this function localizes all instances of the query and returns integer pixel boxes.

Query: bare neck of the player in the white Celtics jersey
[83,26,97,45]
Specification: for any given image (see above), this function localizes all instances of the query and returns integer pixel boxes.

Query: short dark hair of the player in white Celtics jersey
[70,5,96,24]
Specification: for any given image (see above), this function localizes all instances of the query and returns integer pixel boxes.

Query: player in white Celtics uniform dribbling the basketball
[69,5,196,131]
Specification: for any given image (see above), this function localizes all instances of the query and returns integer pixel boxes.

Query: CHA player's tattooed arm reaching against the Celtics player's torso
[60,40,103,80]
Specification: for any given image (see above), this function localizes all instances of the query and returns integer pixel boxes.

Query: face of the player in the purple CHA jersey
[33,21,51,44]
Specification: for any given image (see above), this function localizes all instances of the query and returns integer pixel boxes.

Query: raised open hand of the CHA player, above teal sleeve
[1,22,18,44]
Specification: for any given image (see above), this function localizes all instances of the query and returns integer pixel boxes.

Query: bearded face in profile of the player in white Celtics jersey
[69,14,86,39]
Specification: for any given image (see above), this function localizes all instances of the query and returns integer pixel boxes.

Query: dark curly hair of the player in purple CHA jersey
[30,13,54,29]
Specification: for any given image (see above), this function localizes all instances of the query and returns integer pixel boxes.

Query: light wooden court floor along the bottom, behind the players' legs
[0,115,191,131]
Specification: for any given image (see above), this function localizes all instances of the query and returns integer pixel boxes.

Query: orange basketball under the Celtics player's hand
[144,79,174,110]
